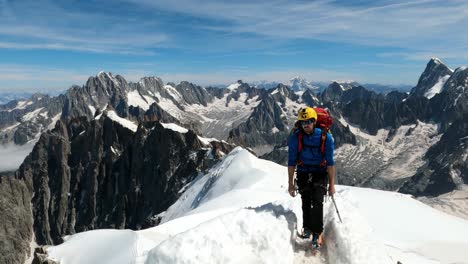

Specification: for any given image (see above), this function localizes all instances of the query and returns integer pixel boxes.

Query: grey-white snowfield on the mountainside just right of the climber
[335,117,442,187]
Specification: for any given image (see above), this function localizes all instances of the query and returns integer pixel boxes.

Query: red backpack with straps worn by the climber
[293,107,333,167]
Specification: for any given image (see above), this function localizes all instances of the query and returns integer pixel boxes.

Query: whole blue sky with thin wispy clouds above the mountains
[0,0,468,92]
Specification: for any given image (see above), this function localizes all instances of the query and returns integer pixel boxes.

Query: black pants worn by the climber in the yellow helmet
[297,171,328,234]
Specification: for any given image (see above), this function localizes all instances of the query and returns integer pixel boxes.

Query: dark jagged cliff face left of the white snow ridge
[0,112,233,263]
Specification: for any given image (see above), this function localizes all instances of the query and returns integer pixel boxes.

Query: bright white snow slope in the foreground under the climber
[48,148,468,264]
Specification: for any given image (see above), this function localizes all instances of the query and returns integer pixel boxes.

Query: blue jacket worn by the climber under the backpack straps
[288,128,335,171]
